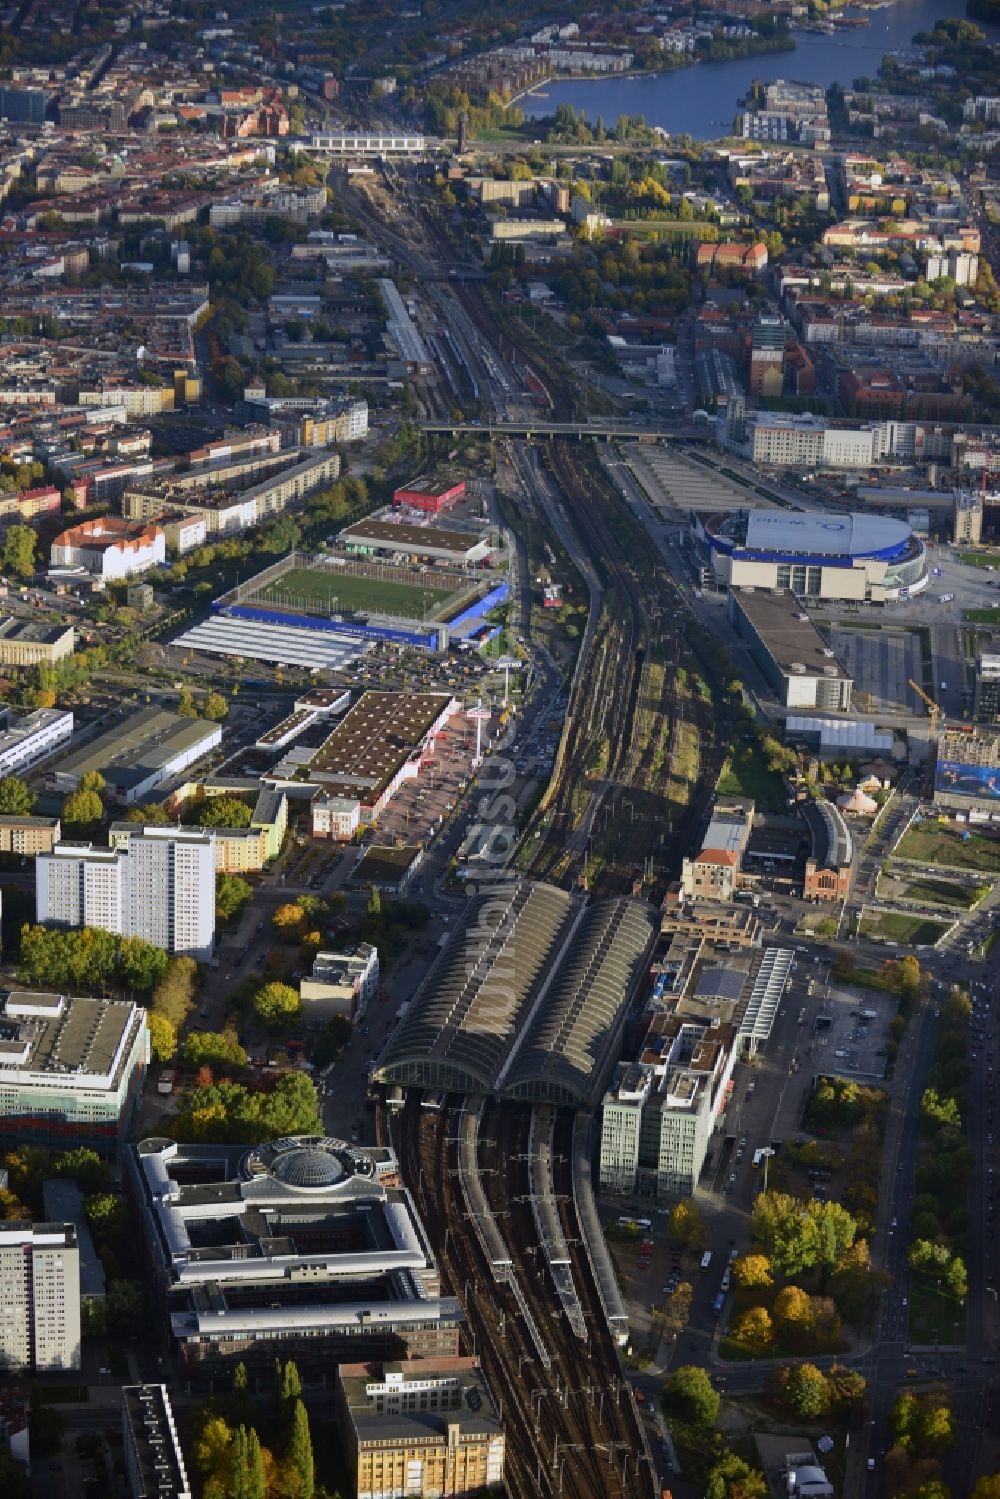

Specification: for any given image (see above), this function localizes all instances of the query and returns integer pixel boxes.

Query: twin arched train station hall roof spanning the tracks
[375,880,654,1103]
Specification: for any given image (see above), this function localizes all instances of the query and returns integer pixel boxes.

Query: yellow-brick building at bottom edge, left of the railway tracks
[336,1358,504,1499]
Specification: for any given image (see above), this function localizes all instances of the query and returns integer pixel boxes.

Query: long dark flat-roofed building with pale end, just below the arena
[727,589,855,714]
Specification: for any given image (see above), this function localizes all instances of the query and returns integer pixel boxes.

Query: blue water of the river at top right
[517,0,1000,141]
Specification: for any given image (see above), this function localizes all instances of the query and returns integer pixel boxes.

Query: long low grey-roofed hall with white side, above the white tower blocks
[49,708,222,806]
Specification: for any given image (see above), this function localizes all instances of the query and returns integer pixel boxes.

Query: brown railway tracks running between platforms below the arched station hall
[393,1100,655,1499]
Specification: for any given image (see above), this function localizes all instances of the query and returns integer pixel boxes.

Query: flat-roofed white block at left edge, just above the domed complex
[0,991,148,1151]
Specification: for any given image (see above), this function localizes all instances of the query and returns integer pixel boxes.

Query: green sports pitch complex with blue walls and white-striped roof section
[174,552,510,670]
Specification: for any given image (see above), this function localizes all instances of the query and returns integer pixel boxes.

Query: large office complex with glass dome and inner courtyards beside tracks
[126,1136,462,1379]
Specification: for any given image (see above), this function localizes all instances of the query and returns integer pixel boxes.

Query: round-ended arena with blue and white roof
[690,510,927,604]
